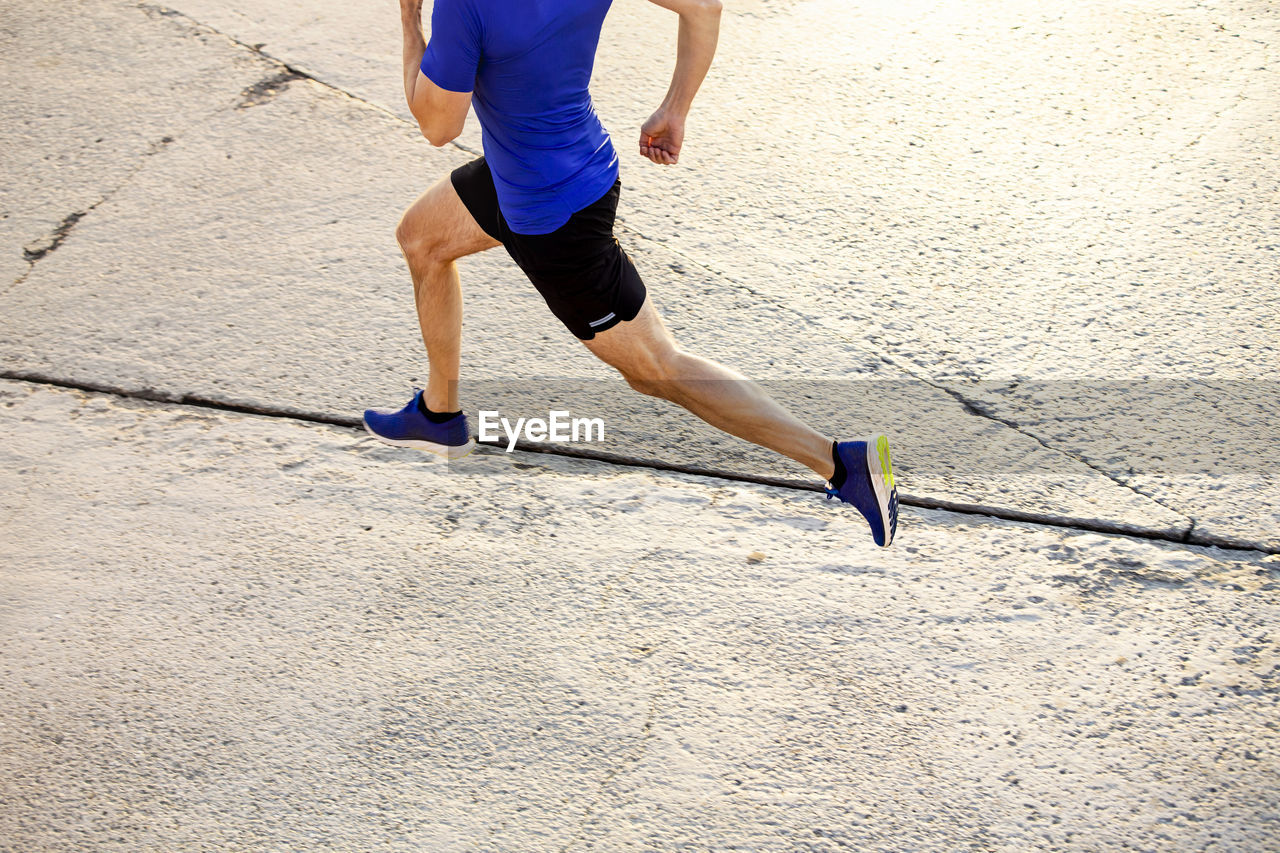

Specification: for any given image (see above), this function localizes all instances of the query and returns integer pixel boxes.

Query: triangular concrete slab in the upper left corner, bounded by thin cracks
[0,0,260,292]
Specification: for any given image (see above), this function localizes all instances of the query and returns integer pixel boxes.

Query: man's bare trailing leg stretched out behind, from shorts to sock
[582,298,835,480]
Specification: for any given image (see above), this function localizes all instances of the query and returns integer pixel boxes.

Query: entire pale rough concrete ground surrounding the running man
[0,0,1280,853]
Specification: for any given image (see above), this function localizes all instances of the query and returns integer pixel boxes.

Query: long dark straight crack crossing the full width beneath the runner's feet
[0,370,1280,555]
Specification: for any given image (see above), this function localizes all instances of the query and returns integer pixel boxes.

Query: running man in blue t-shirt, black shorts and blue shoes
[365,0,897,546]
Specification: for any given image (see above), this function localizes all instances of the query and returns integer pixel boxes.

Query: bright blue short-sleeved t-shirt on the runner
[422,0,618,234]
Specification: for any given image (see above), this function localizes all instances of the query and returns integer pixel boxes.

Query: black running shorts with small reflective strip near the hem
[449,158,645,341]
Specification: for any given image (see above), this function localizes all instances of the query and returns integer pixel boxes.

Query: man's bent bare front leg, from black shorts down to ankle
[396,177,500,412]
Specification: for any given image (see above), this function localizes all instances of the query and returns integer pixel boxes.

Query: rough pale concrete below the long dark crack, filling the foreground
[0,382,1280,850]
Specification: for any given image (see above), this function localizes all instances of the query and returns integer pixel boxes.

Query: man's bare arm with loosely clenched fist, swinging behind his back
[640,0,722,165]
